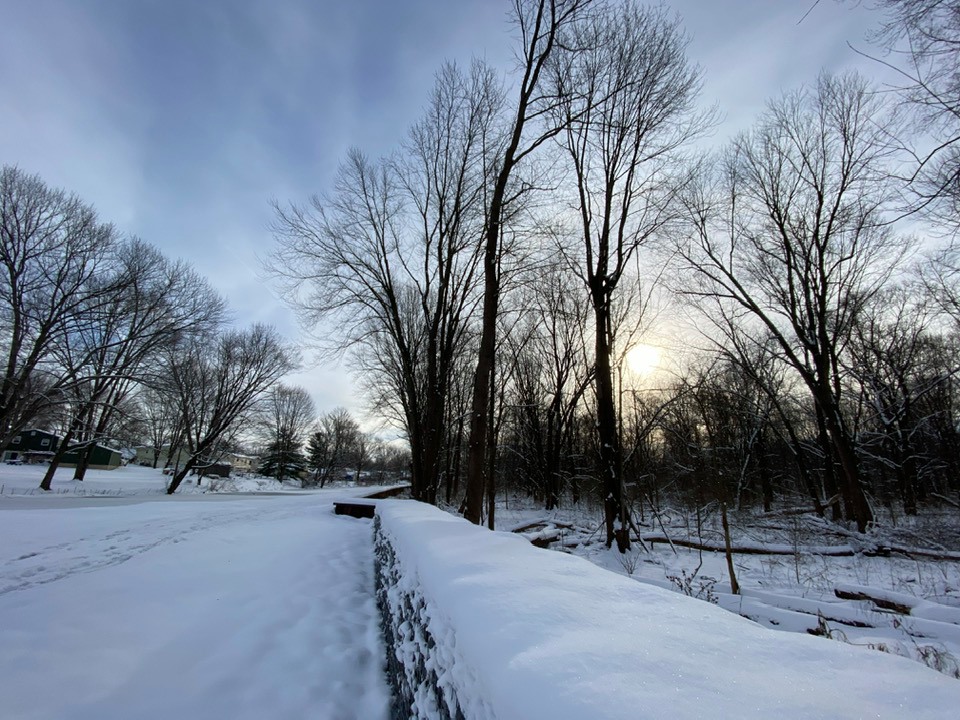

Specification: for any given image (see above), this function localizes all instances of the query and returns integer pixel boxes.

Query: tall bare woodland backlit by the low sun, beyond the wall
[269,0,960,549]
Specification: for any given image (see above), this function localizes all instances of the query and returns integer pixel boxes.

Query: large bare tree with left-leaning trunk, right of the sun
[678,75,909,530]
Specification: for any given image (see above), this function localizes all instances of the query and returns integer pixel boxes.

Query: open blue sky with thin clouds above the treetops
[0,0,878,428]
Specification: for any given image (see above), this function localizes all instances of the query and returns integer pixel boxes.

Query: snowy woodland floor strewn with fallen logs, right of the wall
[484,498,960,677]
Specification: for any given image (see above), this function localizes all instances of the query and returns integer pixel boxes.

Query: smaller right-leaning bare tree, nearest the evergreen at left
[167,325,296,495]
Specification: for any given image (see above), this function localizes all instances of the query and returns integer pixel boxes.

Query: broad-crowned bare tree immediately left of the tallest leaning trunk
[270,63,501,502]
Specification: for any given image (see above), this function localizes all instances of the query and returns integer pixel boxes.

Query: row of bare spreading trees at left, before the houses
[0,166,296,493]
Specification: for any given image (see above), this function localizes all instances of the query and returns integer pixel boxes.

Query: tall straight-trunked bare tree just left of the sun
[551,2,711,552]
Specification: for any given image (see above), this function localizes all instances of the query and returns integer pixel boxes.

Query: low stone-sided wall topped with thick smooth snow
[375,500,960,720]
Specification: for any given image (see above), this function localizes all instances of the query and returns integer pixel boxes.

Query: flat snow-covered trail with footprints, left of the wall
[0,494,388,720]
